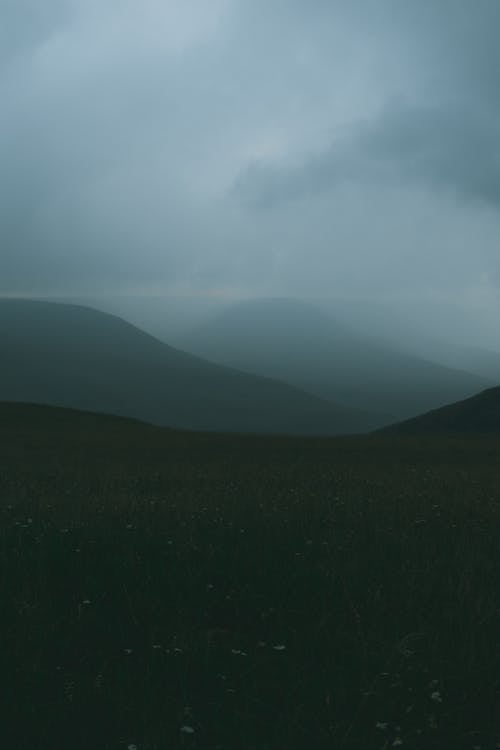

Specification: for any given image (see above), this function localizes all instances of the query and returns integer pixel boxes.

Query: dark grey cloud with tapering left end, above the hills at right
[234,104,500,208]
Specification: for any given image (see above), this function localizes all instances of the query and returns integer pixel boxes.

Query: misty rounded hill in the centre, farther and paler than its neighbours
[177,299,492,424]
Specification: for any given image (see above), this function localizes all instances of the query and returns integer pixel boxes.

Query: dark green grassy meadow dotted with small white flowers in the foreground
[0,409,500,750]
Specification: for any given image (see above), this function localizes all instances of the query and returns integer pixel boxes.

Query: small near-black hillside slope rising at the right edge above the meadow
[380,387,500,436]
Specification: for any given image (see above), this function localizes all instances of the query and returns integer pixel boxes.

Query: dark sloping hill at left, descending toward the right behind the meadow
[0,299,377,434]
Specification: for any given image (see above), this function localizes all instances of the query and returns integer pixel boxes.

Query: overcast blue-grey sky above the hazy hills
[0,0,500,340]
